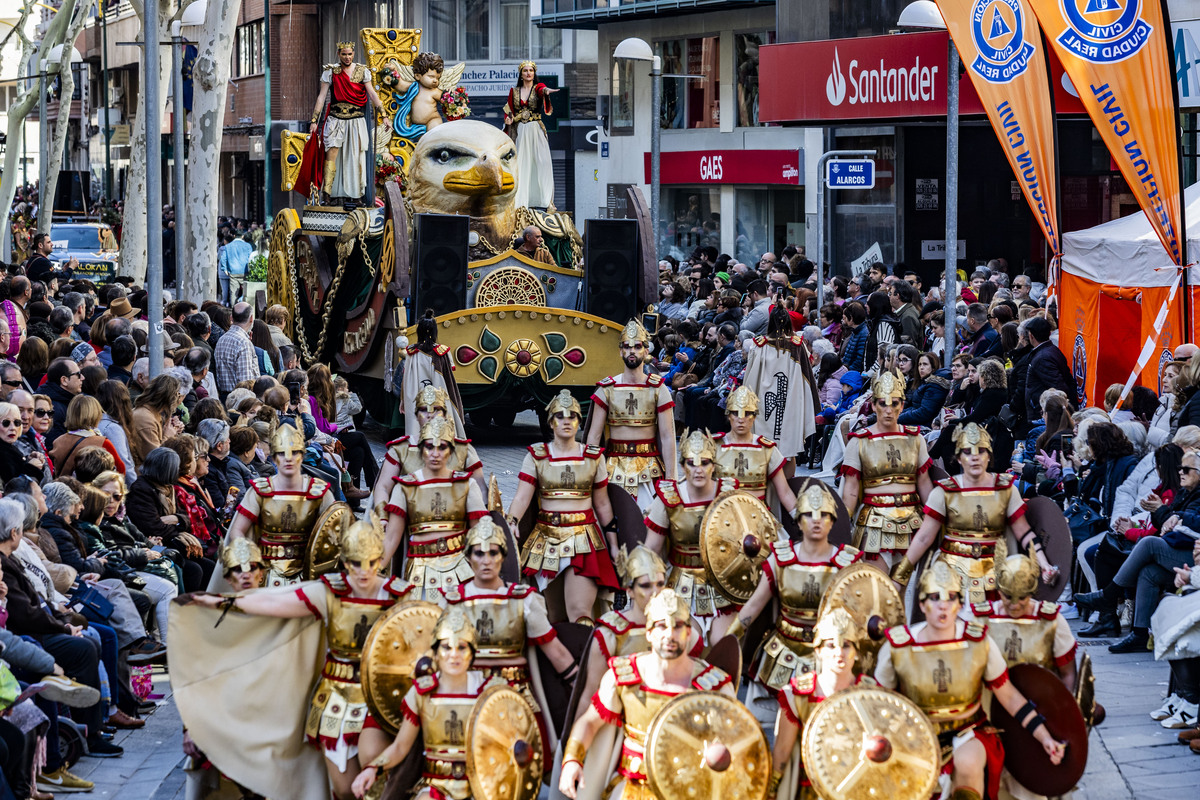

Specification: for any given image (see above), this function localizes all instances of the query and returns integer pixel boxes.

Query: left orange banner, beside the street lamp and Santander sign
[937,0,1070,255]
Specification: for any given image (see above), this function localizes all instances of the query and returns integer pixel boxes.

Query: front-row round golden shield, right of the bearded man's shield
[800,686,941,800]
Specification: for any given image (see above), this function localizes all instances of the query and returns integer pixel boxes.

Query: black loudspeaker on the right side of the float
[583,219,637,325]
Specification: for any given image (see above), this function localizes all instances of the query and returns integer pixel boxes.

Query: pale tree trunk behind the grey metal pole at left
[121,0,175,284]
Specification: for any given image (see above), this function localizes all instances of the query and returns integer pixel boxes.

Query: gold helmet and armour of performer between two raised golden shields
[756,486,862,692]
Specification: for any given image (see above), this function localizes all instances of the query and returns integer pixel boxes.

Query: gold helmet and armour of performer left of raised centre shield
[646,431,738,630]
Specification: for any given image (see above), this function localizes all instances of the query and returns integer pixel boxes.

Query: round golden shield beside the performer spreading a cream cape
[360,600,442,735]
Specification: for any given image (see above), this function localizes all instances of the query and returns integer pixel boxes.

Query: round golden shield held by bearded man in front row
[646,691,770,800]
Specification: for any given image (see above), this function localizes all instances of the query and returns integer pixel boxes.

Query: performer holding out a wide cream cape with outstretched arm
[192,511,413,800]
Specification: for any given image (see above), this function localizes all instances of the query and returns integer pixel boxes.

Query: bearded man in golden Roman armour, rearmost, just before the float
[588,319,676,509]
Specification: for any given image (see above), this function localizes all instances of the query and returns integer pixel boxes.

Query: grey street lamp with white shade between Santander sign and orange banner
[898,0,959,359]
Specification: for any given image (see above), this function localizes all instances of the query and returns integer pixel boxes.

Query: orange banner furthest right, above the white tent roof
[1025,0,1187,266]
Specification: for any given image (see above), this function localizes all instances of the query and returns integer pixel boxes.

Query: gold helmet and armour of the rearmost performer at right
[841,372,932,558]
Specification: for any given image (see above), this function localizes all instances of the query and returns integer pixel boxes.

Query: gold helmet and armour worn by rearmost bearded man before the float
[592,320,674,497]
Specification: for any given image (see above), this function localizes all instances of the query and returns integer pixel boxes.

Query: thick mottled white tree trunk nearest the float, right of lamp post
[176,0,241,302]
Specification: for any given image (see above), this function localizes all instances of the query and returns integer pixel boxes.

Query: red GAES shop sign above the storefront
[646,150,804,186]
